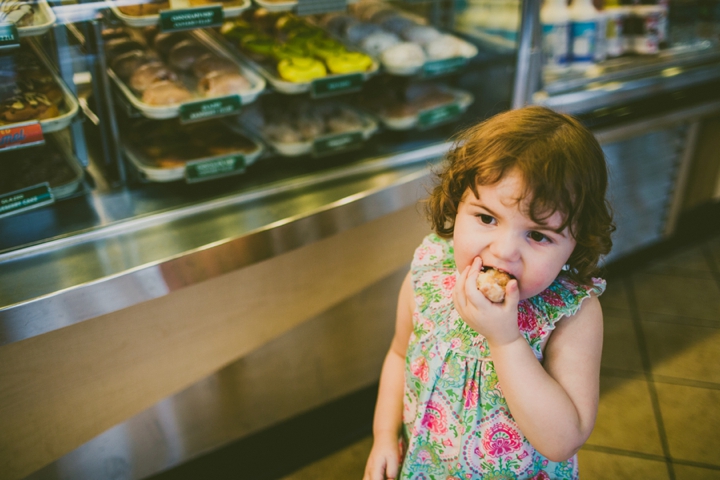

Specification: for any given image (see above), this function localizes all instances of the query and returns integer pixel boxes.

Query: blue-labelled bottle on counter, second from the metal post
[570,0,605,68]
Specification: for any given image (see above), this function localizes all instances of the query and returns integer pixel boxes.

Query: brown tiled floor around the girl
[283,232,720,480]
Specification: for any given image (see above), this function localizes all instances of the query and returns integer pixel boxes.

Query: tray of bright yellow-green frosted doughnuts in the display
[220,9,378,93]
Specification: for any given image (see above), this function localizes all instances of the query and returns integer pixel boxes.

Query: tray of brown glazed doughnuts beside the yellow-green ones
[103,27,265,119]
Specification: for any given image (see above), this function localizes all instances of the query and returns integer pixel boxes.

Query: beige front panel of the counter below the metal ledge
[0,207,427,479]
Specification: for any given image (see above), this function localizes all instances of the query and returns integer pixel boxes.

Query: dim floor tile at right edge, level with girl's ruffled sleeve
[633,273,720,320]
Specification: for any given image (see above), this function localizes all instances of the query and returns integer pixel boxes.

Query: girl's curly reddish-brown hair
[425,106,615,284]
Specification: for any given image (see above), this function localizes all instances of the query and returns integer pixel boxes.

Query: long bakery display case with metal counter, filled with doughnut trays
[0,0,720,480]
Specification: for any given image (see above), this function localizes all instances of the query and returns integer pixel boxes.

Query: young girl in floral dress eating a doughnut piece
[364,107,613,480]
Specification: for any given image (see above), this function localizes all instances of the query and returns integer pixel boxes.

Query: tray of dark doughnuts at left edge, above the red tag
[0,41,78,132]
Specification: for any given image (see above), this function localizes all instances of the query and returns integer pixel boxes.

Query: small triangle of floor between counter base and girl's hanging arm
[281,436,372,480]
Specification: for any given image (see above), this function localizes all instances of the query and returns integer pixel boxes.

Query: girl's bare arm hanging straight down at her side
[363,273,414,480]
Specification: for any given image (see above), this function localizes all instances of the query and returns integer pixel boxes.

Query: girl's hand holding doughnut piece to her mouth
[453,257,520,345]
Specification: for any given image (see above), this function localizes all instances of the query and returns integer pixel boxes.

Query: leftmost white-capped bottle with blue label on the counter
[540,0,570,71]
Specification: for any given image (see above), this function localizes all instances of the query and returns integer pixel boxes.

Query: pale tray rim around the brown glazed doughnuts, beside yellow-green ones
[107,30,265,120]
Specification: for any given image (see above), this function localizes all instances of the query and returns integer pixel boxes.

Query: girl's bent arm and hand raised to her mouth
[454,264,602,461]
